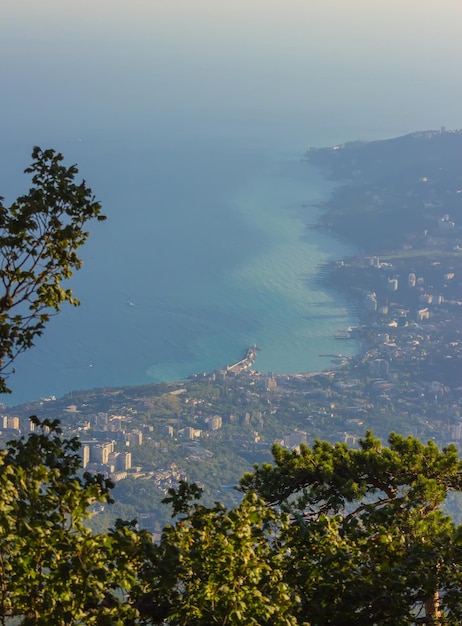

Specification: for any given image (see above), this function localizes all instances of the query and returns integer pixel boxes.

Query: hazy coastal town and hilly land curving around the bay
[1,129,462,532]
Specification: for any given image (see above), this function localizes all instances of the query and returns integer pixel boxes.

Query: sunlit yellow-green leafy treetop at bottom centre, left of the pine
[135,483,298,626]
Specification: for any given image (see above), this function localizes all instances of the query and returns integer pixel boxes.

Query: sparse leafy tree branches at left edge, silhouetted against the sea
[0,147,105,393]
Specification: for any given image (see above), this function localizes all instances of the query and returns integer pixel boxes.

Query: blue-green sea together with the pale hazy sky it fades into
[0,0,462,404]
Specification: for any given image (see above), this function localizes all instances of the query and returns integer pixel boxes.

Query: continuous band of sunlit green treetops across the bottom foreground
[0,418,462,626]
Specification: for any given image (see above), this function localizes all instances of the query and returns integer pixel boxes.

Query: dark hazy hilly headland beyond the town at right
[306,131,462,254]
